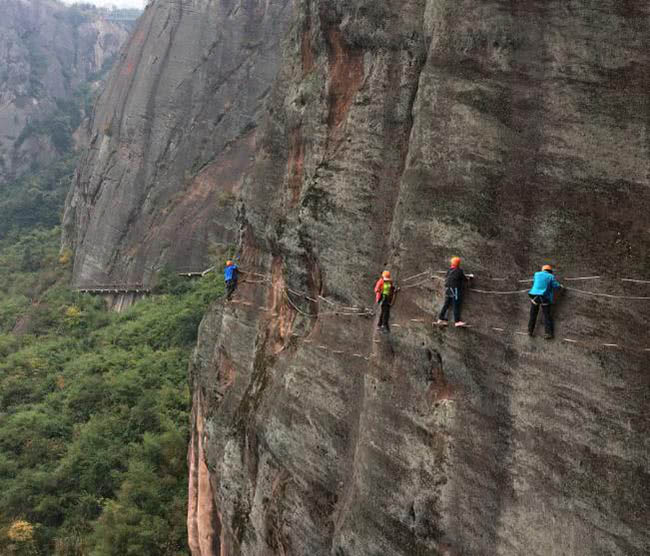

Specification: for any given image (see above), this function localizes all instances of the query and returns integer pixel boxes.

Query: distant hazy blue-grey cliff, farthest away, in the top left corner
[0,0,129,182]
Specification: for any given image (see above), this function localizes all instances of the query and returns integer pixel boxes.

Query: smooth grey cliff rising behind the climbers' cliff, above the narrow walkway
[64,0,291,284]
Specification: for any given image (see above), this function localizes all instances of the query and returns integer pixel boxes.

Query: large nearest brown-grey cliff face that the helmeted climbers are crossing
[186,0,650,556]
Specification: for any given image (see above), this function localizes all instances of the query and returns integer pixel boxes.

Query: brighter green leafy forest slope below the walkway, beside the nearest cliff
[0,229,223,556]
